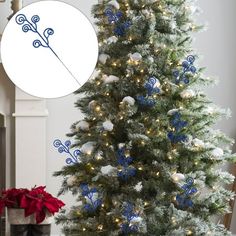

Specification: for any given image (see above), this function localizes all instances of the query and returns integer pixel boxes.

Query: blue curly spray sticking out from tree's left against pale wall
[53,139,81,165]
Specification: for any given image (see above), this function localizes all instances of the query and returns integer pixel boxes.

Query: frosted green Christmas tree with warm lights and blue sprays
[55,0,234,236]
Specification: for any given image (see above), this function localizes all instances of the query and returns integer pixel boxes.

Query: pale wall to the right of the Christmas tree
[194,0,236,234]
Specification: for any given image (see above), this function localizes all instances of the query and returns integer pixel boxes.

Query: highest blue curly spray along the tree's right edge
[173,55,197,84]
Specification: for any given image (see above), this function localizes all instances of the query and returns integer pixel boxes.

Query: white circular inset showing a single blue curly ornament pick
[1,1,98,98]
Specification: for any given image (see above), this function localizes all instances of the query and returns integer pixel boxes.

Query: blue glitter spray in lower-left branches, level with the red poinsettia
[80,184,102,213]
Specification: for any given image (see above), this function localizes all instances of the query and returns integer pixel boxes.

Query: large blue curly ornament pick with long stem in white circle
[15,14,81,85]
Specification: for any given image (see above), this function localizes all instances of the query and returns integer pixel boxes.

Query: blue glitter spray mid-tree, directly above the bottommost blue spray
[117,147,136,180]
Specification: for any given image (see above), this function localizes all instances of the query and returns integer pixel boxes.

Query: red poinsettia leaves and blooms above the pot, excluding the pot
[0,186,65,224]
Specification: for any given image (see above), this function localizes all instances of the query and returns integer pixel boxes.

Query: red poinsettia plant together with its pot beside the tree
[0,186,65,236]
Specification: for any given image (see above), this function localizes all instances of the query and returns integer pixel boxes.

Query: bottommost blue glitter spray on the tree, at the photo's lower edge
[121,202,139,235]
